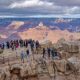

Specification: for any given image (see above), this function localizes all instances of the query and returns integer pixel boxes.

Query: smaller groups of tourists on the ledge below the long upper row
[21,47,61,62]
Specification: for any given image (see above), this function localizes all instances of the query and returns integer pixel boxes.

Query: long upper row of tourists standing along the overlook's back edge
[0,39,39,50]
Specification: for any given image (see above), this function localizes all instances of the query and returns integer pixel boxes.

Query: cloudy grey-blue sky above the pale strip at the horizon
[0,0,80,16]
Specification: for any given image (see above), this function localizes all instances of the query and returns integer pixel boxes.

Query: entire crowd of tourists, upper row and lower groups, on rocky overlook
[0,39,59,62]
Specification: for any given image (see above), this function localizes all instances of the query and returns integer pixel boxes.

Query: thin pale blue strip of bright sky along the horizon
[0,14,80,18]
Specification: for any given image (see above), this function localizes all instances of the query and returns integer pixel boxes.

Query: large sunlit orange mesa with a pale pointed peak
[19,22,80,43]
